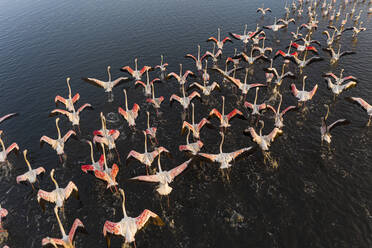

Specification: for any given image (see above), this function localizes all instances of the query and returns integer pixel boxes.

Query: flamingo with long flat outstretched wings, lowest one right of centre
[199,132,252,169]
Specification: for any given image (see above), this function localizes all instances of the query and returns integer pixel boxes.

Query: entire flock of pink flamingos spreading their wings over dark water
[0,0,372,248]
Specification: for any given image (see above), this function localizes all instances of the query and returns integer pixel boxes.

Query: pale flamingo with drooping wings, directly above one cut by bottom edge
[37,169,79,209]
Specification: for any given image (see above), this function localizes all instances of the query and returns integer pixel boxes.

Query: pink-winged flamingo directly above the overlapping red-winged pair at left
[93,112,120,151]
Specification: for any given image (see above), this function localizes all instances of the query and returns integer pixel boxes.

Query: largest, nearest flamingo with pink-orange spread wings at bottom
[103,189,164,248]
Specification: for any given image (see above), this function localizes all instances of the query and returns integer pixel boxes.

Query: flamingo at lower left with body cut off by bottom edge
[41,208,85,248]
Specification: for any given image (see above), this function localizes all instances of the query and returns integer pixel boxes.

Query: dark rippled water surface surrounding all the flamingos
[0,0,372,247]
